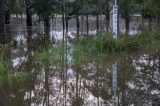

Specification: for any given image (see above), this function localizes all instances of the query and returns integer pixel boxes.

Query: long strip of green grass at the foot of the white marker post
[74,29,160,55]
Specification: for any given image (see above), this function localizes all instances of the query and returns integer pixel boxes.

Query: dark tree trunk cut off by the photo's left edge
[0,0,5,44]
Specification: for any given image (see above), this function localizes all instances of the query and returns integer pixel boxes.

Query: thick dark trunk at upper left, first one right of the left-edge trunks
[25,0,32,26]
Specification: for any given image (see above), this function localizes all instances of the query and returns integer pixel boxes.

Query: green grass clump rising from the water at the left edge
[0,48,28,88]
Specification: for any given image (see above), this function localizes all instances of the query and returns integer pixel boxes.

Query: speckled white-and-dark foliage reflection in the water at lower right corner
[126,52,160,106]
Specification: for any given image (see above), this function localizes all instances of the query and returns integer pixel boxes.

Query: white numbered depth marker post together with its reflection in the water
[112,0,118,106]
